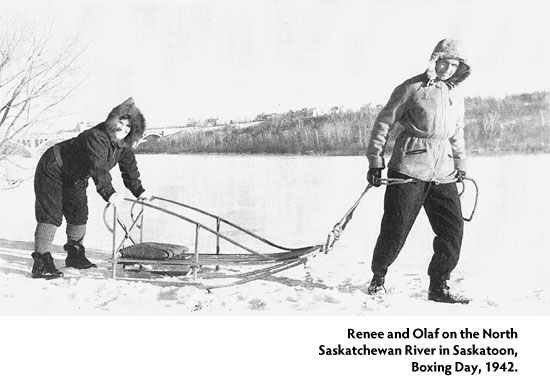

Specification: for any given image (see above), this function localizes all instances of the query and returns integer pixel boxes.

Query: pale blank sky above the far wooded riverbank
[7,0,550,126]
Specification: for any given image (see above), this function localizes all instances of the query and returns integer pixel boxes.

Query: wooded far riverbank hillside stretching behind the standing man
[138,92,550,155]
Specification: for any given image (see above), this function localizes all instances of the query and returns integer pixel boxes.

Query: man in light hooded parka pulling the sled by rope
[367,39,470,303]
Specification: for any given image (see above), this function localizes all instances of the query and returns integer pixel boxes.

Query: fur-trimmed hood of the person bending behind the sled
[105,97,145,147]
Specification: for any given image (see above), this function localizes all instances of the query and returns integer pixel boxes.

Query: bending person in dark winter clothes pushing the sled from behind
[32,98,151,279]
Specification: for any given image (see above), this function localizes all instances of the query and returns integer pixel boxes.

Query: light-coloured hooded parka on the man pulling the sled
[367,39,470,183]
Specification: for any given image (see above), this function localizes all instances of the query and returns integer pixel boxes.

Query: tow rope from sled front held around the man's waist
[324,177,479,254]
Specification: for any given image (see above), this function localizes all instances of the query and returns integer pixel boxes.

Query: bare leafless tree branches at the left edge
[0,20,82,189]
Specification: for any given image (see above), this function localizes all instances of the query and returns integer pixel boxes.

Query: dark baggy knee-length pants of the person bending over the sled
[34,146,88,227]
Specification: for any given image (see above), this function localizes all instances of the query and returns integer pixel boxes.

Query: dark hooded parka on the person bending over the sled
[45,98,145,201]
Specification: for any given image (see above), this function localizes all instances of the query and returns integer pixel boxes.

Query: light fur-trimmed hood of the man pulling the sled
[426,39,471,87]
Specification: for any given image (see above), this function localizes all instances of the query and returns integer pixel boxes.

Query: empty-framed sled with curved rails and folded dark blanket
[103,197,322,289]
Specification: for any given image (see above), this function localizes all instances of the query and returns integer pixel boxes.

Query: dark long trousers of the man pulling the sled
[371,170,464,280]
